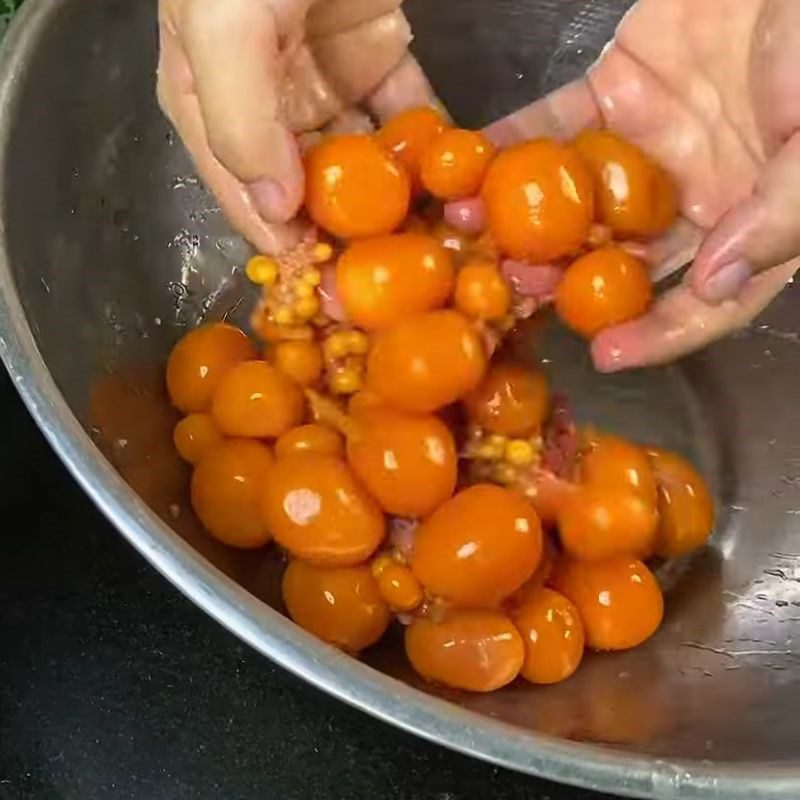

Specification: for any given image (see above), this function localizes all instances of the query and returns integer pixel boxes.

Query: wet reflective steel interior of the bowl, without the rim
[2,0,800,776]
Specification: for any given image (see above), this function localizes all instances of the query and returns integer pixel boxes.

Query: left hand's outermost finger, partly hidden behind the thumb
[158,31,302,253]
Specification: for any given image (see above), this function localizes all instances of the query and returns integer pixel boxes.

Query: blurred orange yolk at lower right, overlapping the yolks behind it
[558,484,658,561]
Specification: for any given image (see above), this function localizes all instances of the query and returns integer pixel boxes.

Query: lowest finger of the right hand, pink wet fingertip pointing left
[592,259,800,372]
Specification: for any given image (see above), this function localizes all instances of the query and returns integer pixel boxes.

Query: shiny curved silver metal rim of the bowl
[0,0,800,800]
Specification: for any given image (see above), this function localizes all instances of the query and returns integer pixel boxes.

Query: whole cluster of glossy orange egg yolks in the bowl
[162,109,714,692]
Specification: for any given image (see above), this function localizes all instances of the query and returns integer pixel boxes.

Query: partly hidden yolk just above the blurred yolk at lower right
[580,434,658,506]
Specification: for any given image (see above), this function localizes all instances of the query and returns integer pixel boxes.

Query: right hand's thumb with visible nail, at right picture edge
[689,133,800,304]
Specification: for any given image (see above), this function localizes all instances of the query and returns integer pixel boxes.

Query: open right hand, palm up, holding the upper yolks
[478,0,800,372]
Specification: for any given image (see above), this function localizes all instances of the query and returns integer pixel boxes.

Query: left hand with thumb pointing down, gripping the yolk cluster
[158,0,433,253]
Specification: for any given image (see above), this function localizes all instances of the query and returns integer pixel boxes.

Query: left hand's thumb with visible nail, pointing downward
[179,0,304,222]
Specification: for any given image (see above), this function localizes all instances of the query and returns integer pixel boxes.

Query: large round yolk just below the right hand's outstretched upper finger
[482,139,594,264]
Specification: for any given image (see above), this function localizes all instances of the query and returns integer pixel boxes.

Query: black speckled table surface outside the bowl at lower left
[0,368,608,800]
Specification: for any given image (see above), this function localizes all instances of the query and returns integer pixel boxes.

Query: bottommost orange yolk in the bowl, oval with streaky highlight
[405,611,525,692]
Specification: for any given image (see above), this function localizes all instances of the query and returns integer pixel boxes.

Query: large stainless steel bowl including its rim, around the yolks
[0,0,800,800]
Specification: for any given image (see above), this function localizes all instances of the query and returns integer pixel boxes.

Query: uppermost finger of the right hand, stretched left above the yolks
[485,79,602,147]
